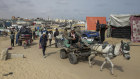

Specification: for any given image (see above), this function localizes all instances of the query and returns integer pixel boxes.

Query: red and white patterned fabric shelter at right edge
[130,15,140,42]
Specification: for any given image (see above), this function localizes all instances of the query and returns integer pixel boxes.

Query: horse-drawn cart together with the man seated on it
[60,30,91,64]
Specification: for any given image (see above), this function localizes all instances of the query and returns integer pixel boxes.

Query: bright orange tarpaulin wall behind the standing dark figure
[86,17,106,30]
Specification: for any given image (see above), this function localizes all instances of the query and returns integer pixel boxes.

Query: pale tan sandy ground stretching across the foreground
[0,37,140,79]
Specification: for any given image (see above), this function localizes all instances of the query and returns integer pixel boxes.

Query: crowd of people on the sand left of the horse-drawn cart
[10,26,59,57]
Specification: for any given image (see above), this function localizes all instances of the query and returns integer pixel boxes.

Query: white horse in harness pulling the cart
[88,41,130,74]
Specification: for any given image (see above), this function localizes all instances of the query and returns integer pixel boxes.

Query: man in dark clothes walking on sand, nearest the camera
[40,32,48,58]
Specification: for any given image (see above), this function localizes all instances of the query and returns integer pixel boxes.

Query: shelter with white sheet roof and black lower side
[109,14,131,39]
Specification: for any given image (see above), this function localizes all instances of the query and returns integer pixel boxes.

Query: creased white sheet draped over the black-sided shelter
[109,14,131,27]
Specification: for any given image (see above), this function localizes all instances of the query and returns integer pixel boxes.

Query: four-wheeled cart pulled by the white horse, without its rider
[60,39,91,64]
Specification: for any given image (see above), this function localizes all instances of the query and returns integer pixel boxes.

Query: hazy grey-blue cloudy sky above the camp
[0,0,140,20]
